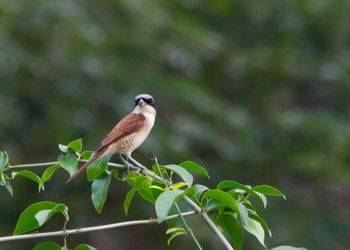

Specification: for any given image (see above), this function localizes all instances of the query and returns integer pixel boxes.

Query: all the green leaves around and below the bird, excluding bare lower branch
[0,139,304,250]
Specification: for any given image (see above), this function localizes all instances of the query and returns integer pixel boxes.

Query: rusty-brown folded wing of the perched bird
[96,113,146,153]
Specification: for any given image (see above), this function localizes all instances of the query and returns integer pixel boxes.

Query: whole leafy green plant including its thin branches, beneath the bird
[0,139,306,250]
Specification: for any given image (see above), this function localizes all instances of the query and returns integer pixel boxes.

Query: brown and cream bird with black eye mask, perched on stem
[67,94,156,182]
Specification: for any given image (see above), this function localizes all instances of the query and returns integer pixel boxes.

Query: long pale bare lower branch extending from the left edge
[0,211,196,242]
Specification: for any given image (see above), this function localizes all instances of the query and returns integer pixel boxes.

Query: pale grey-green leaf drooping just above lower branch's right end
[155,190,184,223]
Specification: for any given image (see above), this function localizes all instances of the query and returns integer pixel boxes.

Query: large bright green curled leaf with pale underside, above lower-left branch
[14,201,69,235]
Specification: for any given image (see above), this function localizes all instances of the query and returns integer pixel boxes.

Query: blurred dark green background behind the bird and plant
[0,0,350,250]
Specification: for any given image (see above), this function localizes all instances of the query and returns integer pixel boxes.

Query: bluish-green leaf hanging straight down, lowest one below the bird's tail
[91,173,111,213]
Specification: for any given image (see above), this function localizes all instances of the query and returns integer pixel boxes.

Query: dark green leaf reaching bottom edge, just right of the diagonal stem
[215,214,243,250]
